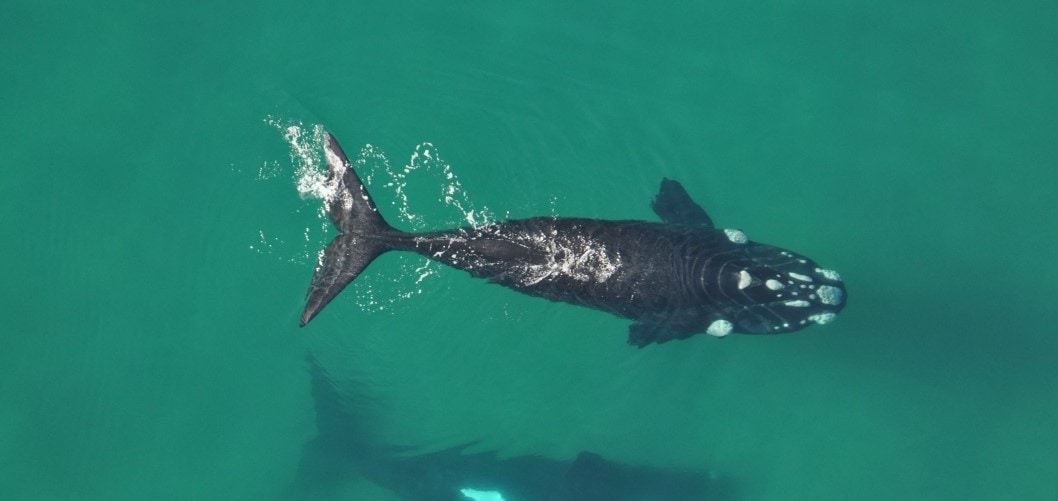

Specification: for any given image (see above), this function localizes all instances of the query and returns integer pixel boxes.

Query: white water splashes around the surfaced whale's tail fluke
[256,117,495,312]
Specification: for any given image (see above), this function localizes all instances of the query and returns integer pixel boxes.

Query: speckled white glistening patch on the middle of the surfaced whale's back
[516,231,621,285]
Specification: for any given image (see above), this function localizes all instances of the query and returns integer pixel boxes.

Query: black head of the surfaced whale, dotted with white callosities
[707,236,847,335]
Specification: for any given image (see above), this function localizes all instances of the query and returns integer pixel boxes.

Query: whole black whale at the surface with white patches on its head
[300,134,846,348]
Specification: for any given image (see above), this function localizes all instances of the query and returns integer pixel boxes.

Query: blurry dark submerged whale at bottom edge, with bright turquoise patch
[289,354,743,501]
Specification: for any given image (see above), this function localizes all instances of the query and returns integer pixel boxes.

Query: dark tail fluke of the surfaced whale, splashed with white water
[300,133,400,327]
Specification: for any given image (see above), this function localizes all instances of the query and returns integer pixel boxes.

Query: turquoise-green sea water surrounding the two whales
[0,1,1058,500]
